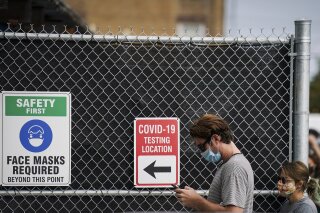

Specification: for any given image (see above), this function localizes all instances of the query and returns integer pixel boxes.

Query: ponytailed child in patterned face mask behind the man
[278,161,320,213]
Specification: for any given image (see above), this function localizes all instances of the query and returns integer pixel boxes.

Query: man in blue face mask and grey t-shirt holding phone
[175,114,254,213]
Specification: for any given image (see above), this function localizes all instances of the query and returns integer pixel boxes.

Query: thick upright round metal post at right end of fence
[293,20,311,165]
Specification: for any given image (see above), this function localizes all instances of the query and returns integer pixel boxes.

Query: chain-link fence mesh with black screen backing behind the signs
[0,24,291,212]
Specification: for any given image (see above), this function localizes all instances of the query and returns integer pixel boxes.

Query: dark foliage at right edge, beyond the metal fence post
[309,63,320,113]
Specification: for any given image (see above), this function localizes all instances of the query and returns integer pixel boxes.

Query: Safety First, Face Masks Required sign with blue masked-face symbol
[1,92,71,186]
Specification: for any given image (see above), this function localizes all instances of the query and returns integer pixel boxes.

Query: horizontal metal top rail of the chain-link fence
[0,31,290,45]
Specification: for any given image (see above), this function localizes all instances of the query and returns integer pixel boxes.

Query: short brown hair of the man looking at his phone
[190,114,234,144]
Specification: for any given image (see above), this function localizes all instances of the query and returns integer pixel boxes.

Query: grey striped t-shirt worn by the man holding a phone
[208,154,254,213]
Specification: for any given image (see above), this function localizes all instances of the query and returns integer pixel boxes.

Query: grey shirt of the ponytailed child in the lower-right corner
[280,196,318,213]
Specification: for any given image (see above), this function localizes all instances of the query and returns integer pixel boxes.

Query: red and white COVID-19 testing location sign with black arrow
[134,118,180,187]
